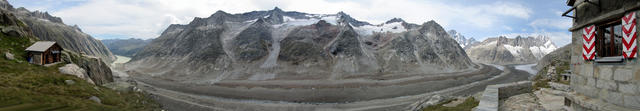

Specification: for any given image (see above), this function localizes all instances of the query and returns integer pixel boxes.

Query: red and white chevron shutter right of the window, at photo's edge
[622,12,638,58]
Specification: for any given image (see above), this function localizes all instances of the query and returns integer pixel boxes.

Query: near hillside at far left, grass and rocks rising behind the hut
[0,2,159,111]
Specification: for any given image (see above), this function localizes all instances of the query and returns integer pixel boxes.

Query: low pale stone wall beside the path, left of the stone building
[473,81,532,111]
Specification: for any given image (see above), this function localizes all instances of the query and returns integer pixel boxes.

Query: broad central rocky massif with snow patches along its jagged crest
[126,8,475,81]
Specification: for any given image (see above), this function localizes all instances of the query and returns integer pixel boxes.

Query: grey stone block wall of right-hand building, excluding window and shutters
[568,0,640,110]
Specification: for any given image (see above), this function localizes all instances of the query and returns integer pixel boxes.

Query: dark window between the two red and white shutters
[596,20,622,57]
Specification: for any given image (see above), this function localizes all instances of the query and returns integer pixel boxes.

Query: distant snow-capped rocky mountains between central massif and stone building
[465,36,556,65]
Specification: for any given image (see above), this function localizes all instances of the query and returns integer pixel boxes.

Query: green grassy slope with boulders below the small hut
[0,33,159,111]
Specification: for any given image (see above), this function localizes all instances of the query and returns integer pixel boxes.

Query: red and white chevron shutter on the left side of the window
[582,25,596,60]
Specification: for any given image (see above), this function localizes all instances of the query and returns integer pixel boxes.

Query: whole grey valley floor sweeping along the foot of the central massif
[115,62,530,110]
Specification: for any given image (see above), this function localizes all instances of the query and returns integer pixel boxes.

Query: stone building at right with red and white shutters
[563,0,640,111]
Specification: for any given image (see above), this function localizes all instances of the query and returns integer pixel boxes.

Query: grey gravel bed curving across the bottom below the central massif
[133,66,529,111]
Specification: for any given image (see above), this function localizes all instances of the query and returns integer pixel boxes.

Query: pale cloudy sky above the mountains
[9,0,572,46]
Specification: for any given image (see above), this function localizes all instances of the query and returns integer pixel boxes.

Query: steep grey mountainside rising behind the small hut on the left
[0,1,115,63]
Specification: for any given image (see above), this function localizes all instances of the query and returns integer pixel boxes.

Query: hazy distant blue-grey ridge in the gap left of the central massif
[101,38,152,57]
